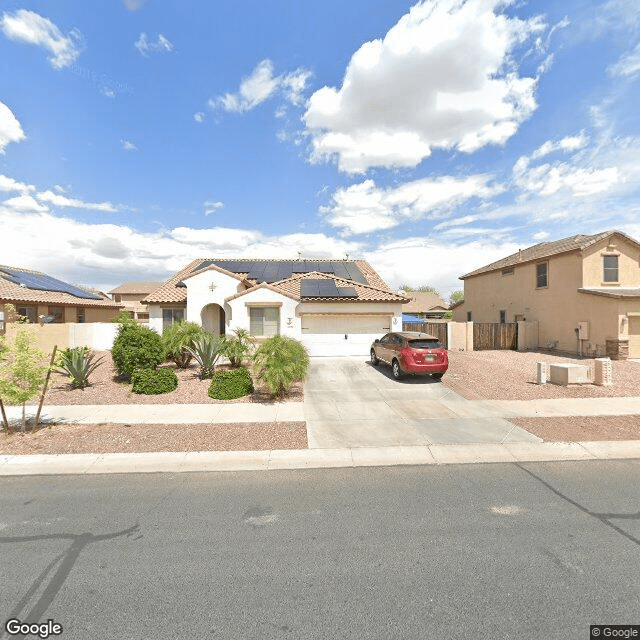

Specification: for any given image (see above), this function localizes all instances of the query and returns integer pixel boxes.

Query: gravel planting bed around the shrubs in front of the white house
[31,351,304,405]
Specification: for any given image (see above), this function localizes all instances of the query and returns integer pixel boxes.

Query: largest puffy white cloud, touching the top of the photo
[304,0,545,173]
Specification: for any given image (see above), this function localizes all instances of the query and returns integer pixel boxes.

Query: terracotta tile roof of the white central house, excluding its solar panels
[142,258,408,304]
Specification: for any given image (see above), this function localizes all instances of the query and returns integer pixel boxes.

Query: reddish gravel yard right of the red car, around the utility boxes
[442,351,640,400]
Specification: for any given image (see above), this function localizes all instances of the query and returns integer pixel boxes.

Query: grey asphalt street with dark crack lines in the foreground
[0,460,640,640]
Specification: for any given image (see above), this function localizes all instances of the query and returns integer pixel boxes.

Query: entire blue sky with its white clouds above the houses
[0,0,640,298]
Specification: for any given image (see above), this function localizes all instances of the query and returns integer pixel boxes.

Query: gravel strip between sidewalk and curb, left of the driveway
[0,422,307,455]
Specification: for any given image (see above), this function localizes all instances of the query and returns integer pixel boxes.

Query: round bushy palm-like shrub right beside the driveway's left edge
[253,336,309,398]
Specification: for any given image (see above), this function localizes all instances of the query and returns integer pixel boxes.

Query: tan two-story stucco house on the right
[453,230,640,359]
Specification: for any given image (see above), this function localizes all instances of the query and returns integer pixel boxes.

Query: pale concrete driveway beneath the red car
[304,357,540,449]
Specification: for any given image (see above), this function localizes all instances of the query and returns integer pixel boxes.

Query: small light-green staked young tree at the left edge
[0,327,49,431]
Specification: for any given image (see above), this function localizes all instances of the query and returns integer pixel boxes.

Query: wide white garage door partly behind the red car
[302,314,391,356]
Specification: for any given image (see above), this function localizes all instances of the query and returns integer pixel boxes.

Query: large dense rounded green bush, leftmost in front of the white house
[111,324,166,377]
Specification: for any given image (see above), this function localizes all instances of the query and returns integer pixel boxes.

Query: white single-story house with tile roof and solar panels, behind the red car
[142,259,408,355]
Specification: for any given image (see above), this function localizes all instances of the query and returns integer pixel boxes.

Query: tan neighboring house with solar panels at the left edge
[0,265,122,330]
